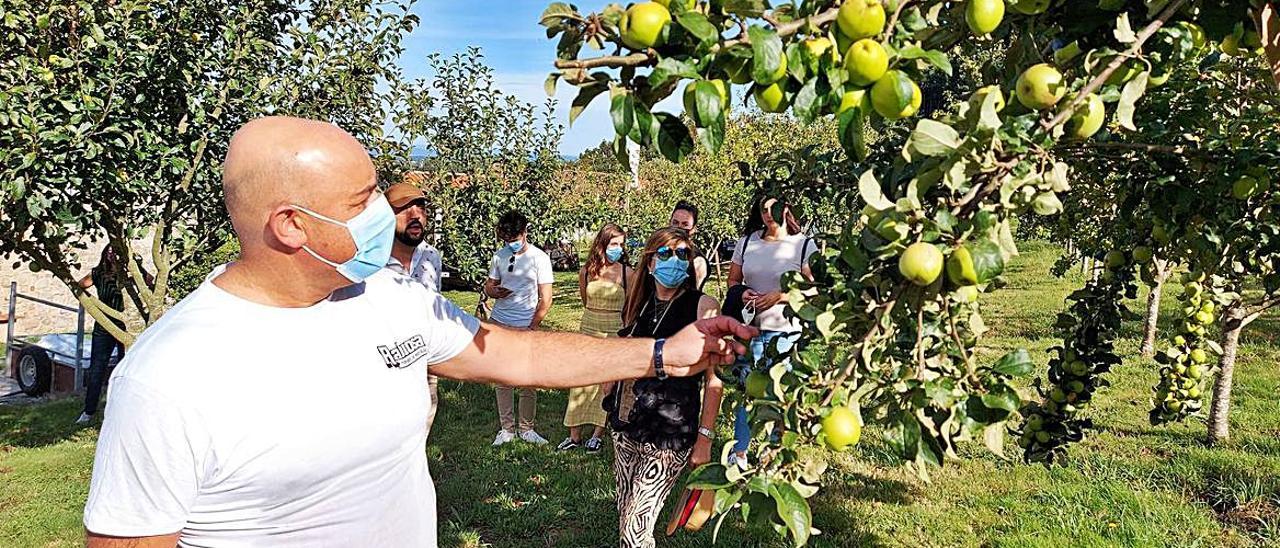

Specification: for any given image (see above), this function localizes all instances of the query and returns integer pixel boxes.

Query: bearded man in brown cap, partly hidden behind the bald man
[385,183,443,437]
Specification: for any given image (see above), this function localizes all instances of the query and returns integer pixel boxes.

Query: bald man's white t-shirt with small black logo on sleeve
[84,269,479,547]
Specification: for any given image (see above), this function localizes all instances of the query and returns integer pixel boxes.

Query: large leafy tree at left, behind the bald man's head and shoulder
[0,0,417,344]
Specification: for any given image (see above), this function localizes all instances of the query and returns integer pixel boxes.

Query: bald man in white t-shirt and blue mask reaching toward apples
[84,118,755,547]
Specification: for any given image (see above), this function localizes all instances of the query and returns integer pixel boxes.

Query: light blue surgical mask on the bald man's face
[293,195,396,283]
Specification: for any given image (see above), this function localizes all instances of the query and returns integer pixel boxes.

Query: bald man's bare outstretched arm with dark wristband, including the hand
[431,316,756,388]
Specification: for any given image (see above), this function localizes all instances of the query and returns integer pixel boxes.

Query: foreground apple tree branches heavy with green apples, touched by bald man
[541,0,1261,544]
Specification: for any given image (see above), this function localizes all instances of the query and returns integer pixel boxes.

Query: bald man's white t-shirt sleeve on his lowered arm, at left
[84,376,209,536]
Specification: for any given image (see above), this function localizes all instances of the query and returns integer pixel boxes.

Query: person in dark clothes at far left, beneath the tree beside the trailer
[76,245,124,424]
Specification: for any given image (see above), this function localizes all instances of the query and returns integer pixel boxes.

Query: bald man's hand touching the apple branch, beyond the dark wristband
[663,316,760,376]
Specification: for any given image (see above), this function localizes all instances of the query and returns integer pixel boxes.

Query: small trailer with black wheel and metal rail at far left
[0,282,119,397]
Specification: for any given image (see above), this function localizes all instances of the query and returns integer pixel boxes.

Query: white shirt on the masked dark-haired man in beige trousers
[489,243,556,328]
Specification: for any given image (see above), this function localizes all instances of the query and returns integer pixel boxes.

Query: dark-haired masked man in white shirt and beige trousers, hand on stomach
[484,211,556,447]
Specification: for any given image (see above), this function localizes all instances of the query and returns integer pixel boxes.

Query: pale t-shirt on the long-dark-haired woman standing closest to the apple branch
[733,232,818,333]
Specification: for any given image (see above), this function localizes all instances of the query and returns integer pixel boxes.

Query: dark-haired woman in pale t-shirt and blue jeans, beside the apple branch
[728,195,817,467]
